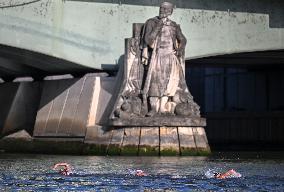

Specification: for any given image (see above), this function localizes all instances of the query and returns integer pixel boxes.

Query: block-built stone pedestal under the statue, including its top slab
[105,115,210,156]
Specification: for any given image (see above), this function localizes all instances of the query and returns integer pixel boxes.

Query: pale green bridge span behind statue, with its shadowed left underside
[0,0,284,80]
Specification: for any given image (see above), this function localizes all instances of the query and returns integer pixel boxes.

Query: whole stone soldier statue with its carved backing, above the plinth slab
[112,2,200,123]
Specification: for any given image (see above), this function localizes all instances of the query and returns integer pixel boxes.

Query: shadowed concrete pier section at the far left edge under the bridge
[0,82,41,136]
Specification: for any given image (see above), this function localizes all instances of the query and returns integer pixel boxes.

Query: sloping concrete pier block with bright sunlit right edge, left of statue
[34,74,98,138]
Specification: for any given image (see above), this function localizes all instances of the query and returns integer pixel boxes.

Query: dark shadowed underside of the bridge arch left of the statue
[0,45,99,82]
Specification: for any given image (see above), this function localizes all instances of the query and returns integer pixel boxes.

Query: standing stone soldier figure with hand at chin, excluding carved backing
[142,2,187,116]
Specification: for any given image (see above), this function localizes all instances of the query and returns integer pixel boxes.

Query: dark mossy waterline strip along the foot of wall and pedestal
[0,138,211,156]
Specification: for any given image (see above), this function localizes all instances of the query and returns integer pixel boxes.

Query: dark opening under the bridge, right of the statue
[186,51,284,150]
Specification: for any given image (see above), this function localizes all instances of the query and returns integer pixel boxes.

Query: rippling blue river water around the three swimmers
[0,152,284,191]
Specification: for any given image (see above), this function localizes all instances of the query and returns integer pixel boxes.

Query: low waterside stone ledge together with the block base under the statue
[0,127,210,156]
